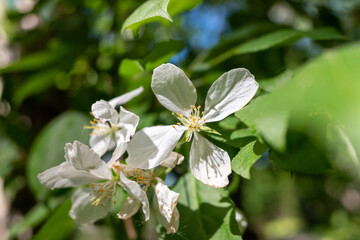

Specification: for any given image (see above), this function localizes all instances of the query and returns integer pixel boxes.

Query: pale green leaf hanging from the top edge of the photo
[121,0,172,31]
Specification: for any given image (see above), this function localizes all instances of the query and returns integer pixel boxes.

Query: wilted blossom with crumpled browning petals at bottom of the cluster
[114,158,180,234]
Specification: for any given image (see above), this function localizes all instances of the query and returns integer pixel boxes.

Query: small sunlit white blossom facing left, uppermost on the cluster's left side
[84,87,143,162]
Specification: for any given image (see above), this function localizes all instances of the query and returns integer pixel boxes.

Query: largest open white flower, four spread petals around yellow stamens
[127,64,258,187]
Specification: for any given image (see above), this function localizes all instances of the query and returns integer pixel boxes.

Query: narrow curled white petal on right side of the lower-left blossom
[119,172,150,221]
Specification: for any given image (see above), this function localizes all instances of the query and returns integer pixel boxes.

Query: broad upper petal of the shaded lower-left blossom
[65,141,111,179]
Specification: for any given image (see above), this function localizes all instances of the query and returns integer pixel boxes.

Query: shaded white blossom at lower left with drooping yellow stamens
[38,141,149,224]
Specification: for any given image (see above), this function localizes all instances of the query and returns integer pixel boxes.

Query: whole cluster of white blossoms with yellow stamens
[38,64,258,233]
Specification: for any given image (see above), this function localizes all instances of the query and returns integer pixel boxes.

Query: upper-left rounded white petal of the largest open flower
[151,63,197,115]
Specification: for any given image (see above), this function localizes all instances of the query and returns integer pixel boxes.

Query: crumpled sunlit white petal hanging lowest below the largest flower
[154,178,180,223]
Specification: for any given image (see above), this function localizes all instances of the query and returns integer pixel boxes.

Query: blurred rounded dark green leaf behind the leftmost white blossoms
[26,111,89,200]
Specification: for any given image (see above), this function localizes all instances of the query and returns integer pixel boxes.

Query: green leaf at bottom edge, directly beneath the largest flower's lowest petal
[165,174,242,240]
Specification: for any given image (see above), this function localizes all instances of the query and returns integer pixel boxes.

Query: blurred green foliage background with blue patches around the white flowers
[0,0,360,240]
